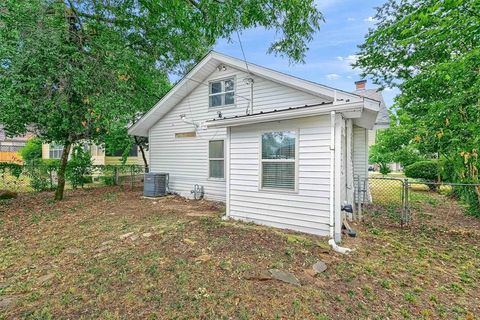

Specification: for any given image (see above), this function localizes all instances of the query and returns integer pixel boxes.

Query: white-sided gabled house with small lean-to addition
[129,52,380,240]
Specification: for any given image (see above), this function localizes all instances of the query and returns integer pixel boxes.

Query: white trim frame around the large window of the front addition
[258,128,300,193]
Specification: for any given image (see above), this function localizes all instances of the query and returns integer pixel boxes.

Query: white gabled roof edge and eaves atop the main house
[128,51,378,136]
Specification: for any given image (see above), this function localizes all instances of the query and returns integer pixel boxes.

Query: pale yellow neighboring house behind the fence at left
[42,144,148,165]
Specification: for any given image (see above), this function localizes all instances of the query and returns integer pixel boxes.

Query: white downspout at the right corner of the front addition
[328,111,352,253]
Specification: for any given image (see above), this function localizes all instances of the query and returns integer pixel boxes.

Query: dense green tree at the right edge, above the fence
[356,0,480,182]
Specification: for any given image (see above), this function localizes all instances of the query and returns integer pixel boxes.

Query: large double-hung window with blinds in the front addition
[261,131,297,191]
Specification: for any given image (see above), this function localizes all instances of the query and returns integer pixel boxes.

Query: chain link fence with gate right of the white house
[355,177,480,226]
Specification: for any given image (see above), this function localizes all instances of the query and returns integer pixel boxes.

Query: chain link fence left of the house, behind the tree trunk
[0,161,145,192]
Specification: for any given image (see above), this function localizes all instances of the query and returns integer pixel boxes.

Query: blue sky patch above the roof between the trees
[214,0,398,106]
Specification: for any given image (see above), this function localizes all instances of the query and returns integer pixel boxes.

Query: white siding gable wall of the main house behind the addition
[149,67,325,201]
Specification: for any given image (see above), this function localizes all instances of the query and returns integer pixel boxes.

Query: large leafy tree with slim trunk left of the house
[0,0,322,199]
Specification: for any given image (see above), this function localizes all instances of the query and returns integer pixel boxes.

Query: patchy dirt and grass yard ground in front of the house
[0,188,480,319]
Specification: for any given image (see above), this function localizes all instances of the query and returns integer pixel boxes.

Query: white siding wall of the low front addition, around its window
[228,116,331,235]
